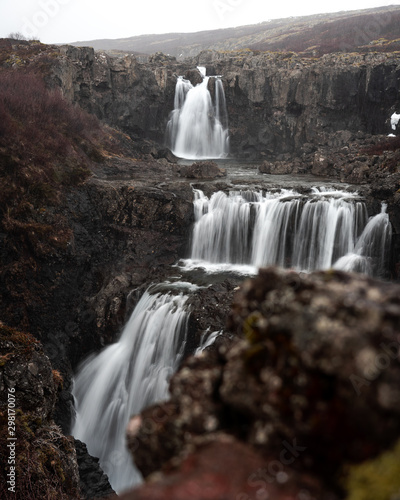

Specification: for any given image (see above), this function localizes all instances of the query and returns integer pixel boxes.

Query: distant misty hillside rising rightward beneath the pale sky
[71,5,400,59]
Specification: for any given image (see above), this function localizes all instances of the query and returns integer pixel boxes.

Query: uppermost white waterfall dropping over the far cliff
[166,68,229,159]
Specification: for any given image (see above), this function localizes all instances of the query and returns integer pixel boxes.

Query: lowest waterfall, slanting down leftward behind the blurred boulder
[72,289,188,491]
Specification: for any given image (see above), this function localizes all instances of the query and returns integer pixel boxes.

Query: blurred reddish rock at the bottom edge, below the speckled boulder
[120,434,326,500]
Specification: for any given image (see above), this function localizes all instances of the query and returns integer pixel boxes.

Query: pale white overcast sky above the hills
[0,0,400,43]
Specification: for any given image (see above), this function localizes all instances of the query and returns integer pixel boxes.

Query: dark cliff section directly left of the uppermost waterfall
[49,46,190,143]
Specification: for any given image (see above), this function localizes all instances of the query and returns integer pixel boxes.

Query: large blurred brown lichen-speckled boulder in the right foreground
[127,268,400,499]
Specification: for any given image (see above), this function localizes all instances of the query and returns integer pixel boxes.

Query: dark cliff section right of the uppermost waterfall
[196,51,400,157]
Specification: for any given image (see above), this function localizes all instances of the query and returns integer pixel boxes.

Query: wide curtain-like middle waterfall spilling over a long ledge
[185,188,391,277]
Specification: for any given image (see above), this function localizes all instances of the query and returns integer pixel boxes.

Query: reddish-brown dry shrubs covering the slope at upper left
[0,69,106,255]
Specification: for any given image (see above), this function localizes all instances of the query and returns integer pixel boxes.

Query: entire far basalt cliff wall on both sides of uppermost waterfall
[51,46,400,159]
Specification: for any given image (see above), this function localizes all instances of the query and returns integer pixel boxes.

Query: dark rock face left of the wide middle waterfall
[0,150,193,432]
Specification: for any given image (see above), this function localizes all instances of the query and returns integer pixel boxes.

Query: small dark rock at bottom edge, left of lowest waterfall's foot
[74,439,115,499]
